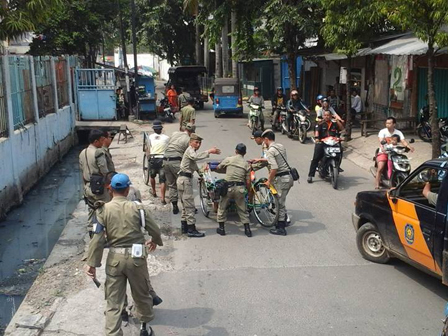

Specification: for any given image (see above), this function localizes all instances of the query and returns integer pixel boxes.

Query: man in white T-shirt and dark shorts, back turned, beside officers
[146,119,170,205]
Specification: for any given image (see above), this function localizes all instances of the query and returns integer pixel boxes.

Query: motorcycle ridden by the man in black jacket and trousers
[317,136,342,189]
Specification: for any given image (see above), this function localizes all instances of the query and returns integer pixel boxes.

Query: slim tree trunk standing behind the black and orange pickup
[427,43,440,159]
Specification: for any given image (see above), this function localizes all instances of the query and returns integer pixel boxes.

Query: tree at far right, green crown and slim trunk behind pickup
[383,0,448,158]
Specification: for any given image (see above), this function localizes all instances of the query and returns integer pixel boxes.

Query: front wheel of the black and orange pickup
[356,223,390,264]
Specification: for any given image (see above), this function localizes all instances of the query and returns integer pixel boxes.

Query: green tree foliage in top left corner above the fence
[0,0,62,41]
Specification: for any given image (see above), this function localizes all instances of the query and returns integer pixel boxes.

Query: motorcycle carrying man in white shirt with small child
[370,139,414,188]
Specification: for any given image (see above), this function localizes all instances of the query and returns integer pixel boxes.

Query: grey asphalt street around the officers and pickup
[152,106,448,336]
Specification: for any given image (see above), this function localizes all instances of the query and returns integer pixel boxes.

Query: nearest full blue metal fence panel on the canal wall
[9,56,34,129]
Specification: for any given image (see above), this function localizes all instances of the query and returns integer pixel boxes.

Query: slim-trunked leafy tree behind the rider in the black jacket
[322,0,388,141]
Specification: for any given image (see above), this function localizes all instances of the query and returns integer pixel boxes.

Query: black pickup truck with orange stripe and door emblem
[352,159,448,285]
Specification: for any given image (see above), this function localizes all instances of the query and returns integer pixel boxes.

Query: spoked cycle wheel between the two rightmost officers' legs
[253,184,279,227]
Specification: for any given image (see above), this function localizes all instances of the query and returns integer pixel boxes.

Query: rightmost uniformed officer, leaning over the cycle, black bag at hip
[263,131,294,236]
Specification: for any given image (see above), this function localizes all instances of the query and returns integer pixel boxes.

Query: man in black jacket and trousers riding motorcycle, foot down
[306,110,344,183]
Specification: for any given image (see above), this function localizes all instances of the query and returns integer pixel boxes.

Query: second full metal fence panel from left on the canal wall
[34,56,55,118]
